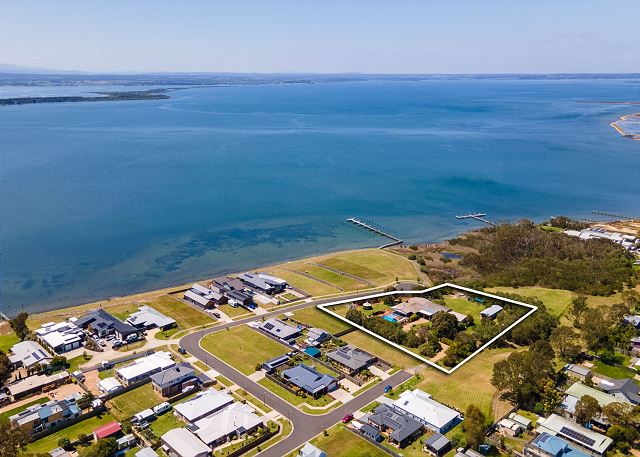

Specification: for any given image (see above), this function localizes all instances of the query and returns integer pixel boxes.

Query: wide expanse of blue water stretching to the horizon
[0,80,640,313]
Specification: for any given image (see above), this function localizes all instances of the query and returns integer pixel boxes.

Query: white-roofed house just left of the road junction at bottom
[194,403,264,449]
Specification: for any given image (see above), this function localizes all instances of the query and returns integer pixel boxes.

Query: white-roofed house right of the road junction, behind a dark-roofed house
[393,389,460,433]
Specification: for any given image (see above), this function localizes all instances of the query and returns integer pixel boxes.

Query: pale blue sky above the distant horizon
[0,0,640,73]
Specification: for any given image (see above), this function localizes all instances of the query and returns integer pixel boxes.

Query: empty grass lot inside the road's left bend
[200,325,287,375]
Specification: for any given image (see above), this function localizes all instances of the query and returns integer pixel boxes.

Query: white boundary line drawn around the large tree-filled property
[318,282,538,374]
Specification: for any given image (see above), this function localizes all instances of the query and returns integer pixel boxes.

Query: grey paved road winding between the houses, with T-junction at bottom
[180,292,412,457]
